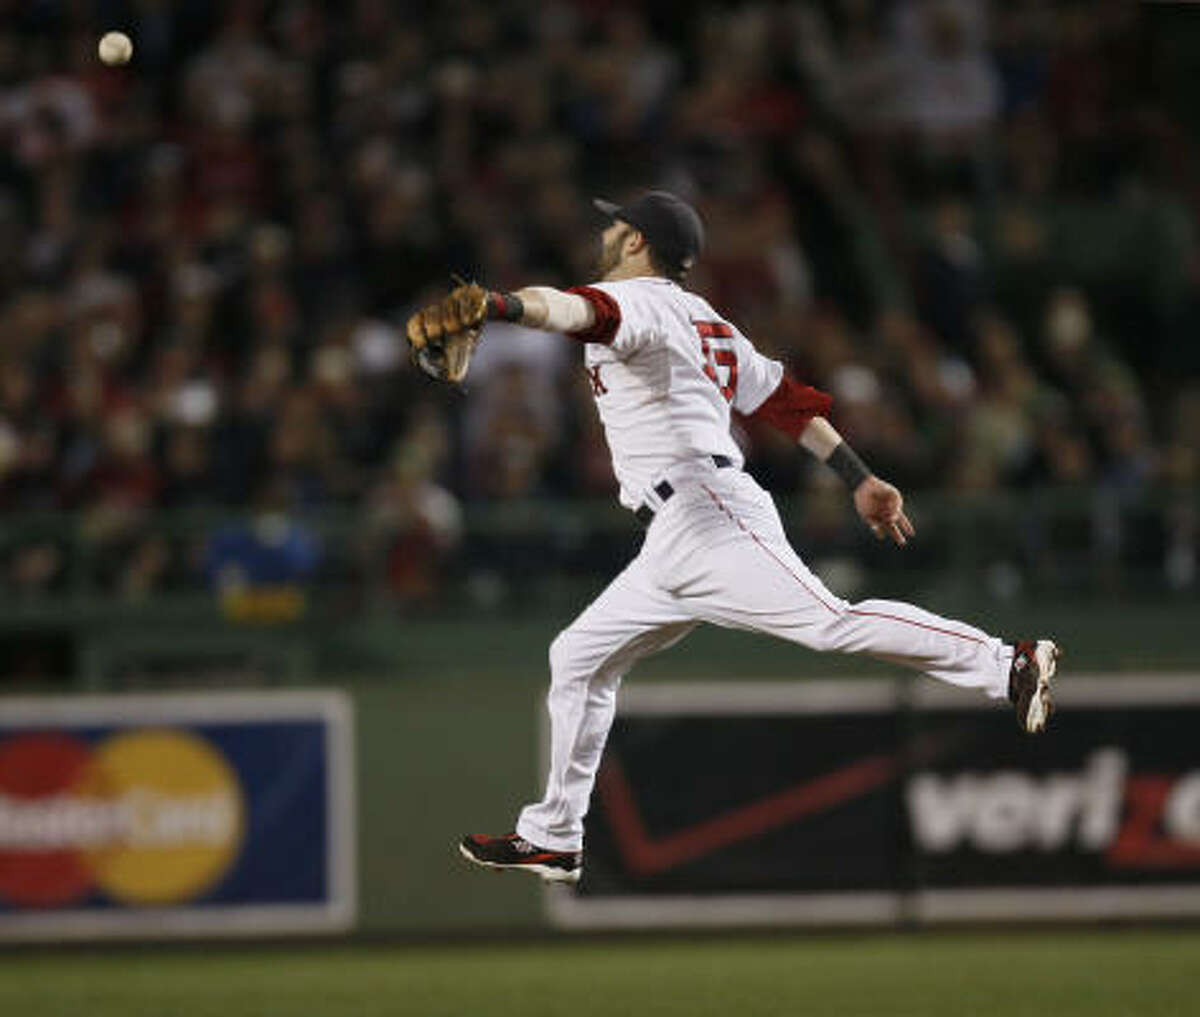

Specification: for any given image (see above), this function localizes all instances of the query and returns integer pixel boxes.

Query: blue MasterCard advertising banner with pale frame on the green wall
[0,691,355,939]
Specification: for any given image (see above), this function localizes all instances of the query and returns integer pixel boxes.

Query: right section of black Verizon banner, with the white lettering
[904,674,1200,920]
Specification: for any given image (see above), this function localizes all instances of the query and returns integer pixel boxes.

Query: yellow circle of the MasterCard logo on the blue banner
[78,730,246,904]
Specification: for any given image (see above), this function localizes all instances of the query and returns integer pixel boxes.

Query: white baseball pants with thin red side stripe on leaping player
[516,459,1013,851]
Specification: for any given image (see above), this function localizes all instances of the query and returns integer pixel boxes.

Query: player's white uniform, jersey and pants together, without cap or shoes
[516,277,1013,851]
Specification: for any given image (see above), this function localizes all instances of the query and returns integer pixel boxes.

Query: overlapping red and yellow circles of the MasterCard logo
[0,729,246,908]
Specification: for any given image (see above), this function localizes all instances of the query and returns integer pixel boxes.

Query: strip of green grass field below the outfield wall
[0,929,1200,1017]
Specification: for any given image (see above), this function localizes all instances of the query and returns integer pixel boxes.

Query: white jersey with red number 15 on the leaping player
[584,276,784,509]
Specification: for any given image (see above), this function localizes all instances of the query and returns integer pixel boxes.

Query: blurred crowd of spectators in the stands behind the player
[0,0,1200,596]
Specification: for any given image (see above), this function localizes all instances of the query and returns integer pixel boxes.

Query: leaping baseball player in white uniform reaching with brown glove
[408,191,1060,883]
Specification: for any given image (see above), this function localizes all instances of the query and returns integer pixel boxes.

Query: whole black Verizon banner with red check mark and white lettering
[547,675,1200,927]
